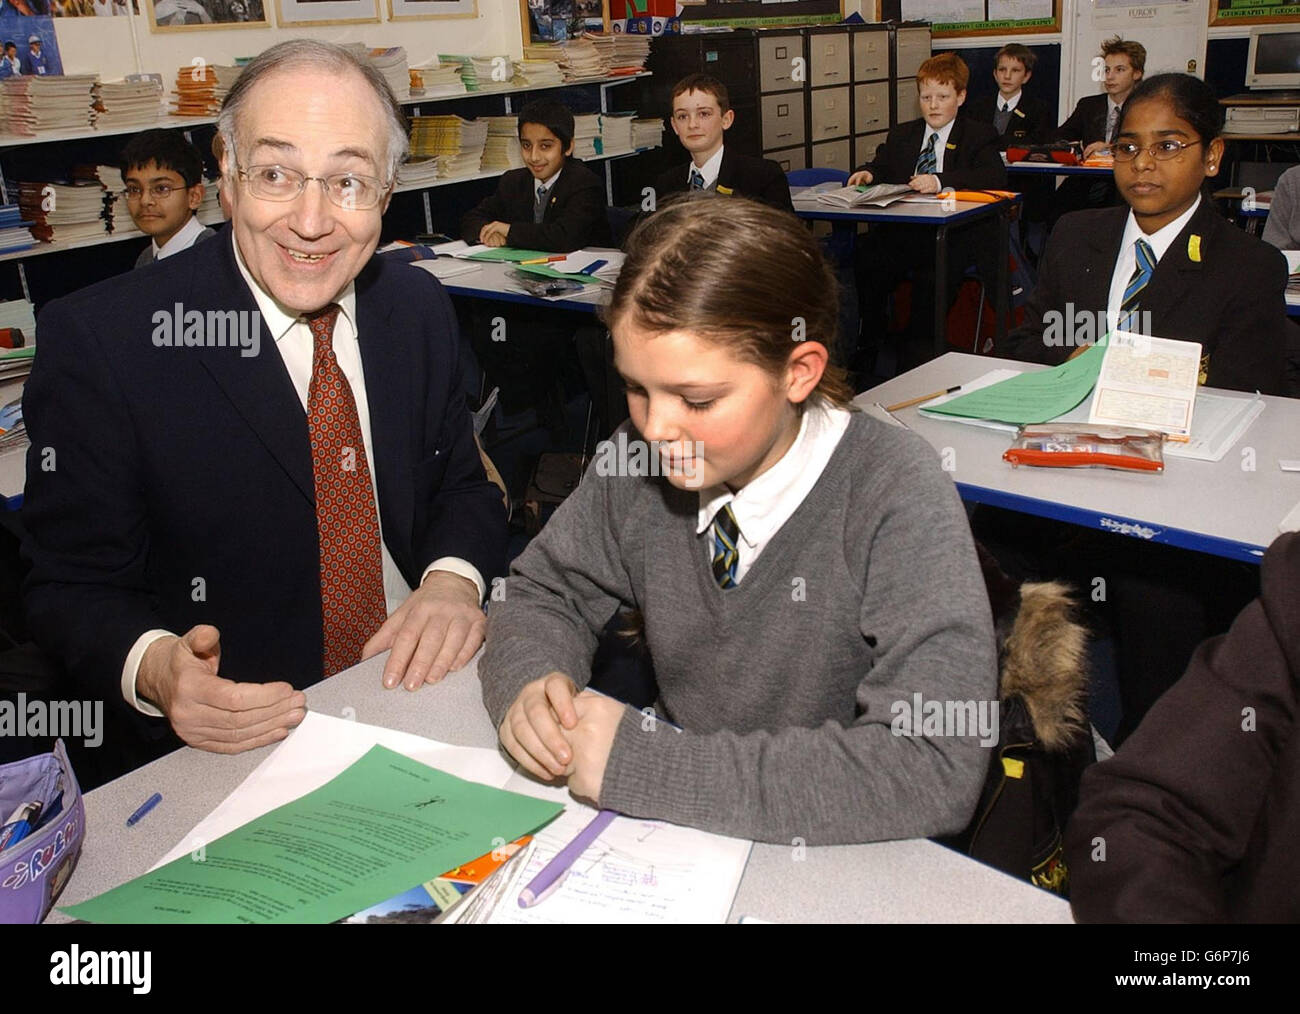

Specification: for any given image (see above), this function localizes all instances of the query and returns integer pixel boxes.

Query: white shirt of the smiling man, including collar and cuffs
[122,235,486,718]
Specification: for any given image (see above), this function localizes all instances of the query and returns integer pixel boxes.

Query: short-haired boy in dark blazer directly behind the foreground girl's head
[655,74,794,215]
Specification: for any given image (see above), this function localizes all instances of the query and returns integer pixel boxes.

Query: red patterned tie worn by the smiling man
[307,303,387,676]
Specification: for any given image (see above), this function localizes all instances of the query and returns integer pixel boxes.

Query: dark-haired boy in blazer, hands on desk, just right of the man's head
[460,100,610,254]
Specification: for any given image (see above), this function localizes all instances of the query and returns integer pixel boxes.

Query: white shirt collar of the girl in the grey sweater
[696,398,852,584]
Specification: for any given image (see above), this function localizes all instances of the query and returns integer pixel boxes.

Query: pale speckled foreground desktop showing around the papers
[48,655,1071,923]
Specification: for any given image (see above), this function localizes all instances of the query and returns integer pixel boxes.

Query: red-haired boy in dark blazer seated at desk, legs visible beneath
[849,53,1006,380]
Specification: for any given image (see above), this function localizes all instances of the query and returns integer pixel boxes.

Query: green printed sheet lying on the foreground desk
[61,746,564,923]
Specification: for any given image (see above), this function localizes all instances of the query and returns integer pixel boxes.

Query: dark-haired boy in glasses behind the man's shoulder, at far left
[118,130,216,268]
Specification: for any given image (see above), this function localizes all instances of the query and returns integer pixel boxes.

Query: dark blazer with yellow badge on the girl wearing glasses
[1008,196,1287,394]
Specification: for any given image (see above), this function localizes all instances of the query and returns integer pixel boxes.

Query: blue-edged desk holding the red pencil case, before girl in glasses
[855,352,1300,563]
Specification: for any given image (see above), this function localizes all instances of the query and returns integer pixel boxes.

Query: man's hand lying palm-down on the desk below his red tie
[361,571,488,690]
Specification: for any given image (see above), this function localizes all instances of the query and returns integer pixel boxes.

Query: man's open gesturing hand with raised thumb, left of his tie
[135,625,307,754]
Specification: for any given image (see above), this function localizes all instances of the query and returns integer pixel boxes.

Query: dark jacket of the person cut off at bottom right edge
[1065,534,1300,923]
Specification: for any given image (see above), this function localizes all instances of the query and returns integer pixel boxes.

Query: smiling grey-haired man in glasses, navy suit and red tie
[23,39,506,769]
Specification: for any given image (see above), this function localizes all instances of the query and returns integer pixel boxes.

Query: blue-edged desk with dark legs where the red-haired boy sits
[790,187,1021,356]
